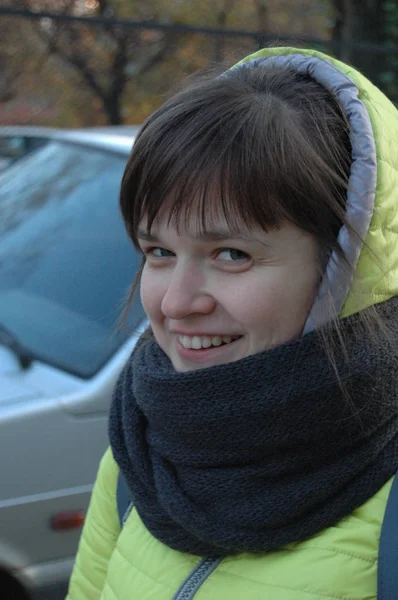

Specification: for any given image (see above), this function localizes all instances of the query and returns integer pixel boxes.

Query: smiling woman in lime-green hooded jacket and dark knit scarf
[68,48,398,600]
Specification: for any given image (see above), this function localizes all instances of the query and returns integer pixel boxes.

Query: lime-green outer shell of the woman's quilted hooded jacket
[67,48,398,600]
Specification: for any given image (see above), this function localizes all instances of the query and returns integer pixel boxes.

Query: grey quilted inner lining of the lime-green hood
[233,54,377,334]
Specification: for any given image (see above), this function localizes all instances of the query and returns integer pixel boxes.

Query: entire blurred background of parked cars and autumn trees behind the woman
[0,0,398,600]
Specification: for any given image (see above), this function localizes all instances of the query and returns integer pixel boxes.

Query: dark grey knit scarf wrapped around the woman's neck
[110,299,398,556]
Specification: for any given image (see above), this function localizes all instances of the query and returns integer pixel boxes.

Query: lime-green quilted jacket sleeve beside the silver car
[66,448,120,600]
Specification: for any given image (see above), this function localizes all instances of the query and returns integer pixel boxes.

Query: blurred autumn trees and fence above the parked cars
[0,0,398,127]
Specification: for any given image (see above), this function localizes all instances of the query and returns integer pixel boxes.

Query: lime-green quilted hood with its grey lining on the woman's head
[232,48,398,332]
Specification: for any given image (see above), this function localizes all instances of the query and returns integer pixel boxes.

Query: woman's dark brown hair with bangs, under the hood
[120,65,351,316]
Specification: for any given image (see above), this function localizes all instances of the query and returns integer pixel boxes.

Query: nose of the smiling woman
[161,263,216,319]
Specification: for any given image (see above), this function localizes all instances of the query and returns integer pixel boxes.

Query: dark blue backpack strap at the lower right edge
[377,475,398,600]
